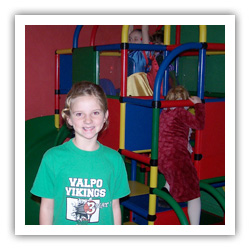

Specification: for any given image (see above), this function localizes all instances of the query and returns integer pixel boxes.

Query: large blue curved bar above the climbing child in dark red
[153,43,202,101]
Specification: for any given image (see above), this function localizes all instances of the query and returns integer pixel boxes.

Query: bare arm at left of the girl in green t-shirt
[39,198,54,225]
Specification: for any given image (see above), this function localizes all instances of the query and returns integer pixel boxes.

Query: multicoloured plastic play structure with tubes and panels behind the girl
[26,25,225,225]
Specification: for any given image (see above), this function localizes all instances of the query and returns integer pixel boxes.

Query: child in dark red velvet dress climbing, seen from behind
[158,86,205,225]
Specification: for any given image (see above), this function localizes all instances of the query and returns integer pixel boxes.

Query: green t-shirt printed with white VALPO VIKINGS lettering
[31,140,130,225]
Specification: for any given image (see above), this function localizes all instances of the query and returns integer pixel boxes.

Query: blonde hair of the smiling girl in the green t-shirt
[62,81,108,131]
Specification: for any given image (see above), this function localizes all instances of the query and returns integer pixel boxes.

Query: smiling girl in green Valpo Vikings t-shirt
[31,82,130,225]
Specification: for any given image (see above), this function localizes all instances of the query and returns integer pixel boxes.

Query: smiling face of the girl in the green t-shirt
[68,96,108,145]
